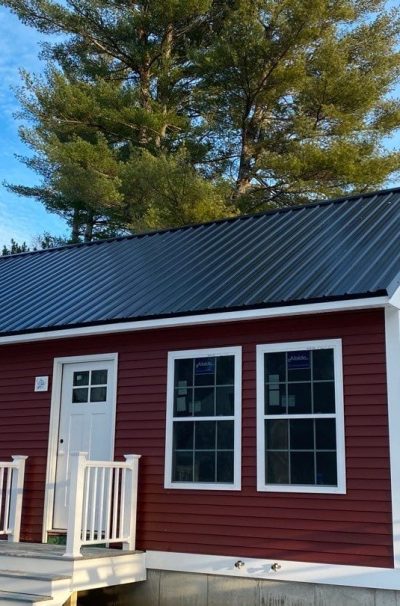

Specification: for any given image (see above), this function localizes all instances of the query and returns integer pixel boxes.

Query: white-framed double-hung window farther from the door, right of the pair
[257,339,345,493]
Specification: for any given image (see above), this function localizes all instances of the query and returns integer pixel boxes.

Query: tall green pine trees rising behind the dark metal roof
[0,0,400,241]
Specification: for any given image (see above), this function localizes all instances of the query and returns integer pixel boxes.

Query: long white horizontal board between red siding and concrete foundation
[146,551,400,590]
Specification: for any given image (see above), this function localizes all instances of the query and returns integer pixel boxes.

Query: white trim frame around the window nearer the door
[164,347,242,490]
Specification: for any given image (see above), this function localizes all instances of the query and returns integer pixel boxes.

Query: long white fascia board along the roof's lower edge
[0,297,389,345]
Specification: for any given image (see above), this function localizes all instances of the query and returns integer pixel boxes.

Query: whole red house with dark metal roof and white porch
[0,189,400,606]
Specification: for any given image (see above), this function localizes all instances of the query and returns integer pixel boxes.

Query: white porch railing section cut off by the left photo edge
[0,455,28,543]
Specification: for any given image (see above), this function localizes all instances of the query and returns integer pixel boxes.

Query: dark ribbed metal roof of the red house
[0,188,400,335]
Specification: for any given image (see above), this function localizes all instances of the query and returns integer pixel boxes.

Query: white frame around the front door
[42,353,118,543]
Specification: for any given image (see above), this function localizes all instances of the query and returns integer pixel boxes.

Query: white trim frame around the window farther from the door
[257,339,346,494]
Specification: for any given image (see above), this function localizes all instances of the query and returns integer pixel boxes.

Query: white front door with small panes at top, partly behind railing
[53,358,116,529]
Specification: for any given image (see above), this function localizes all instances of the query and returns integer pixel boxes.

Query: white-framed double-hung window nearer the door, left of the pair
[165,347,241,490]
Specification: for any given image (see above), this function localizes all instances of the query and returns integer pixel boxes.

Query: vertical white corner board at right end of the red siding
[385,307,400,569]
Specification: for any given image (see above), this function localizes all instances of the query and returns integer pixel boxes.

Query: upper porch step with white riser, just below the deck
[0,570,71,603]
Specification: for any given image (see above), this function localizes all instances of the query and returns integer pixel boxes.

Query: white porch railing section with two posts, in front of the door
[64,452,140,558]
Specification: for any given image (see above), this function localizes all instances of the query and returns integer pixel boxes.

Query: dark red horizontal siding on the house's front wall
[0,311,393,567]
